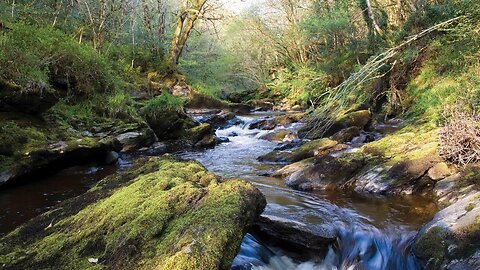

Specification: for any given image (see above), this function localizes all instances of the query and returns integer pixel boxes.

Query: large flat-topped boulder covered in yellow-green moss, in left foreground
[0,157,266,269]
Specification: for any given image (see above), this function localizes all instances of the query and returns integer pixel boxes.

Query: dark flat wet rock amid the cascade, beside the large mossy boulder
[256,214,337,251]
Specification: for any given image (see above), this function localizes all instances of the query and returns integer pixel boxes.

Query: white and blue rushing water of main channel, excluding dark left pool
[180,116,436,270]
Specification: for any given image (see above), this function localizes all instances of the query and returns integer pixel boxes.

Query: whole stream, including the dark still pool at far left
[0,114,437,270]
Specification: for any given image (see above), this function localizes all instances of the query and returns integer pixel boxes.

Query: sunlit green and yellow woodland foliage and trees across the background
[0,0,480,123]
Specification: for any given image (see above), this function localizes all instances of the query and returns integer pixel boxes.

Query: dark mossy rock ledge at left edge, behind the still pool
[0,113,127,188]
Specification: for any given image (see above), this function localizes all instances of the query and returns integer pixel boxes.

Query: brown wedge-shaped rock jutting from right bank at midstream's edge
[286,154,366,190]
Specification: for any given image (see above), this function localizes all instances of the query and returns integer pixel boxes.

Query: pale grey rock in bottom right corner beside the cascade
[414,194,480,269]
